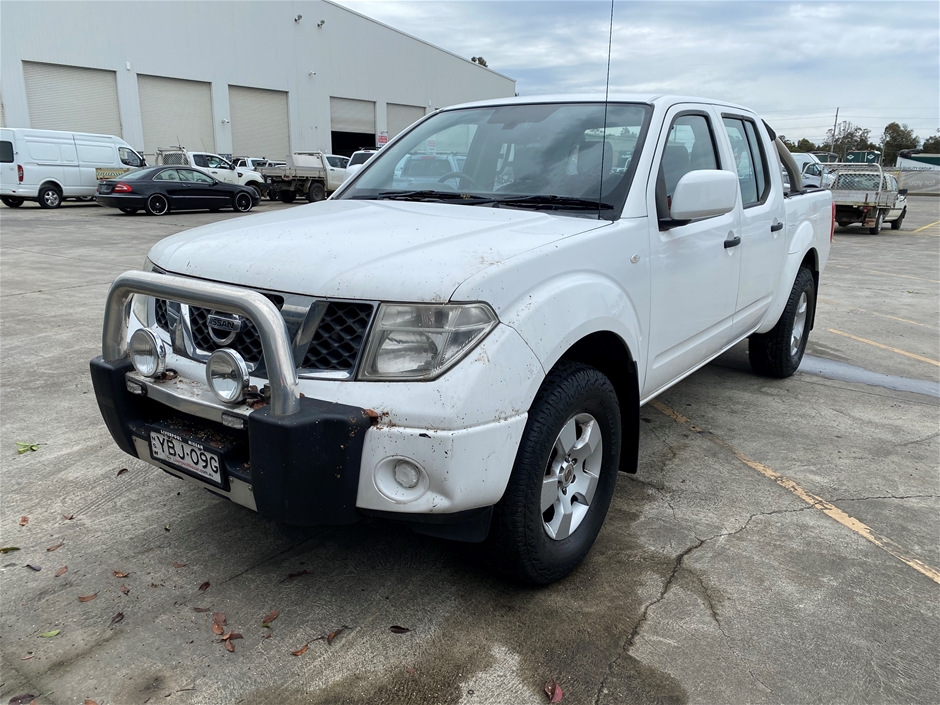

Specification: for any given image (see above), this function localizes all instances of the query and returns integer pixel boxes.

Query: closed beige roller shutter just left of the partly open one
[228,86,290,159]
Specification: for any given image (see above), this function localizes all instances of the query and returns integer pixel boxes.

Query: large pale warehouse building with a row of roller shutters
[0,0,515,159]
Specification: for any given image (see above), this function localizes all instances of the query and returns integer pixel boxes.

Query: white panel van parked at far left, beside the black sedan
[0,127,146,208]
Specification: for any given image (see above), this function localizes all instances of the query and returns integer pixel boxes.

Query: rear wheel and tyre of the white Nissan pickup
[747,267,816,378]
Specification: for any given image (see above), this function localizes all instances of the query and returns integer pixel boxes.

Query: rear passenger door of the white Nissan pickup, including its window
[721,111,795,338]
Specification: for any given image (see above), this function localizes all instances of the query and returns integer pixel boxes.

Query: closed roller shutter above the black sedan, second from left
[137,74,215,154]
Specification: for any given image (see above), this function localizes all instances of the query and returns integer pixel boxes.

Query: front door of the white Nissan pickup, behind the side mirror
[643,104,741,396]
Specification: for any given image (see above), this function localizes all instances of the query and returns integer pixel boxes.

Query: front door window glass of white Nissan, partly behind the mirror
[656,115,719,217]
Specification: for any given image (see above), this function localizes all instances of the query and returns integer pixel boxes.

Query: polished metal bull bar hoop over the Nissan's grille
[101,272,300,416]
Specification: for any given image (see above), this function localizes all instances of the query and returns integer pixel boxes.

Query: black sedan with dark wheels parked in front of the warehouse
[95,166,260,215]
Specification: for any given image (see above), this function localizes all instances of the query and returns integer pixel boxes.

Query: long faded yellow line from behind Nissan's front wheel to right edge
[650,399,940,584]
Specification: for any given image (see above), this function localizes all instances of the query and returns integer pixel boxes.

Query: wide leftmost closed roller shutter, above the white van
[23,61,123,137]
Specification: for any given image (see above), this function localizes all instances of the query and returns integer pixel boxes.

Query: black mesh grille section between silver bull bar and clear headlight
[302,302,373,370]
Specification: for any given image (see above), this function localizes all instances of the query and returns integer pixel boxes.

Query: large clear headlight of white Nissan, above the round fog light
[359,304,498,380]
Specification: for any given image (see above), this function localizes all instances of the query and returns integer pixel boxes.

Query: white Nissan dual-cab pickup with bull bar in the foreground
[91,96,833,584]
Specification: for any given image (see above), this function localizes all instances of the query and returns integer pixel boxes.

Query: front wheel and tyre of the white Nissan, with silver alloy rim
[482,362,621,585]
